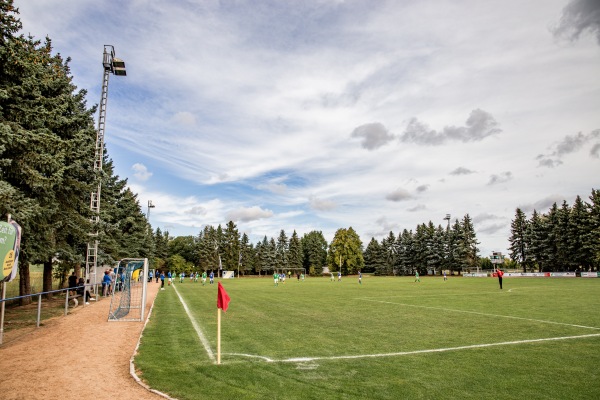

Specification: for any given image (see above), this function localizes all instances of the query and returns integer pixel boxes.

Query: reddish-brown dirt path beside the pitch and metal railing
[0,283,162,400]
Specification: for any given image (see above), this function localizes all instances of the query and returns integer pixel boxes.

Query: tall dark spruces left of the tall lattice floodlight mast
[0,0,94,304]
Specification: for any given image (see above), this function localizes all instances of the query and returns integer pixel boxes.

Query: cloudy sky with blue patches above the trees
[15,0,600,256]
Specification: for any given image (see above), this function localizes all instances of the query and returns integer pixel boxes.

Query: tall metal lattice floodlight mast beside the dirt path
[85,44,127,289]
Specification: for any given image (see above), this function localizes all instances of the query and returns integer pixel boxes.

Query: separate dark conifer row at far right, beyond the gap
[509,189,600,272]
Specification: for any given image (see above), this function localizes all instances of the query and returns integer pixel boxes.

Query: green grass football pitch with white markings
[135,277,600,399]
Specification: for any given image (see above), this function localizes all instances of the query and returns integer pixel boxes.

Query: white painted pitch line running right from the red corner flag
[224,333,600,363]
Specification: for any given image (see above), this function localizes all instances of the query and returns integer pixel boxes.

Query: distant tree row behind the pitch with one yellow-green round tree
[153,214,482,275]
